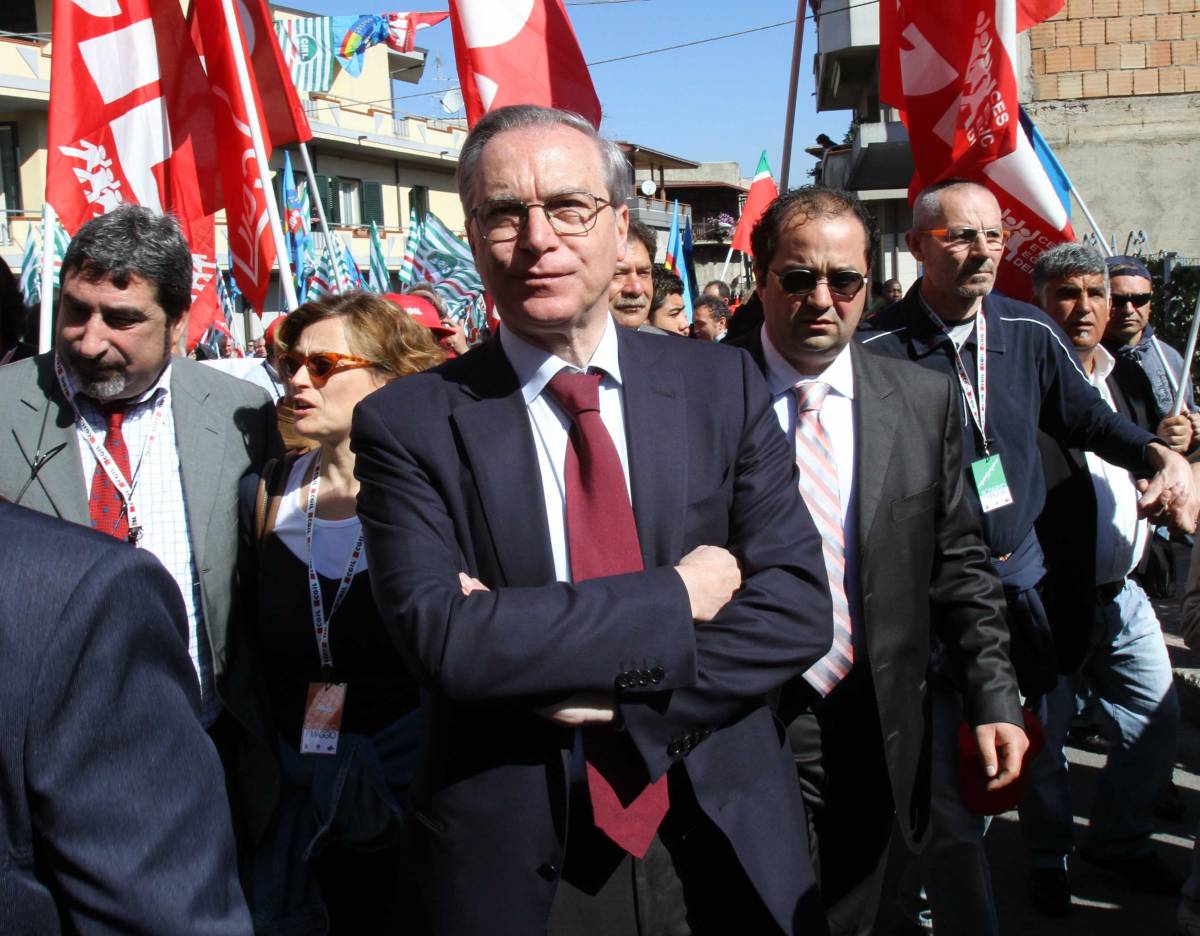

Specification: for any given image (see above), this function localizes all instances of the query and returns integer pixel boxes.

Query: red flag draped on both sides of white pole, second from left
[191,0,312,314]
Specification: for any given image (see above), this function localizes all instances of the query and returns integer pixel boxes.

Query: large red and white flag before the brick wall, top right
[880,0,1075,299]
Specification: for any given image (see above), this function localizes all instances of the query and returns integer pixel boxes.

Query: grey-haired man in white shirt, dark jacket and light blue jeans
[1020,244,1182,916]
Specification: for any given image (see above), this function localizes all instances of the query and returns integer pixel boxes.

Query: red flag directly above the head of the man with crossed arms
[450,0,600,127]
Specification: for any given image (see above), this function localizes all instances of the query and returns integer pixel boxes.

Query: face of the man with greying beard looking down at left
[54,271,187,401]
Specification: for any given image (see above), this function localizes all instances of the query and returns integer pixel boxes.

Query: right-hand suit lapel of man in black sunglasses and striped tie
[850,344,896,552]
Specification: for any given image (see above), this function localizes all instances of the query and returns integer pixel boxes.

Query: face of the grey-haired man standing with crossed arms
[464,126,629,338]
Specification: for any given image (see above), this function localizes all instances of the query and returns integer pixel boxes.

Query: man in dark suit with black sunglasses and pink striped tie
[739,188,1027,934]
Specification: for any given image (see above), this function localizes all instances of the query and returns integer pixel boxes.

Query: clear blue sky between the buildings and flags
[295,0,851,185]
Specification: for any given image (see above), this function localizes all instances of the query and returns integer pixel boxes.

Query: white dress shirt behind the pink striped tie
[762,328,863,659]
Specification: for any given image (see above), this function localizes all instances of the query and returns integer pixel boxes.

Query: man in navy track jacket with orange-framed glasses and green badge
[858,179,1196,936]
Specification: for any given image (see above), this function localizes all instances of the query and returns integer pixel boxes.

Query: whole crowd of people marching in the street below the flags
[7,106,1200,936]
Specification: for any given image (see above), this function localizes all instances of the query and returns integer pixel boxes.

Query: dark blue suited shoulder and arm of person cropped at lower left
[0,502,251,936]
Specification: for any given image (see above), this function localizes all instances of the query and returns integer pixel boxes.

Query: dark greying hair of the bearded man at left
[62,204,192,322]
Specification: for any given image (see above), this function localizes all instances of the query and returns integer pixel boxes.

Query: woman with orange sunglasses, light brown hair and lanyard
[230,293,443,934]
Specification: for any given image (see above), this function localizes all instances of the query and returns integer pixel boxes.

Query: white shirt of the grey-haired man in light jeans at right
[1085,344,1150,584]
